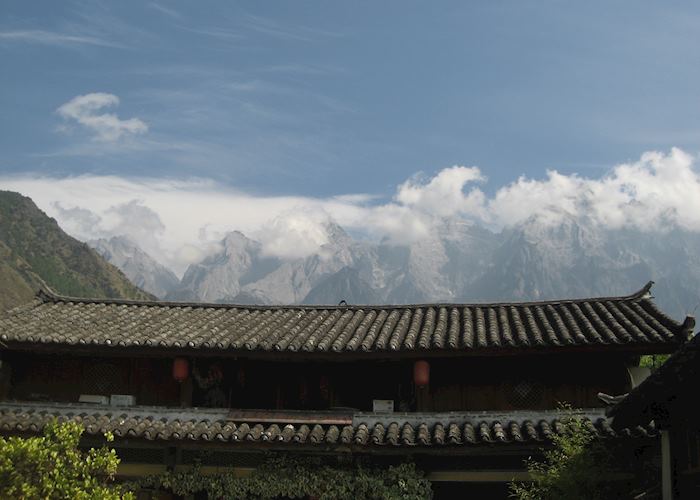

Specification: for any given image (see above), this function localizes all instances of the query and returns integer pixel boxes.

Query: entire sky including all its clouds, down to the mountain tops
[0,0,700,272]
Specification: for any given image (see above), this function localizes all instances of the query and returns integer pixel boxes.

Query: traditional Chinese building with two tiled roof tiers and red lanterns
[0,283,694,497]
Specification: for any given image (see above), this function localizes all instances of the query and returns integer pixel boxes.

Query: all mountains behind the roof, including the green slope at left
[0,191,700,318]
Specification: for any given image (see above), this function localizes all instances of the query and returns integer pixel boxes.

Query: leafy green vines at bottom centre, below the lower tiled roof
[129,455,433,500]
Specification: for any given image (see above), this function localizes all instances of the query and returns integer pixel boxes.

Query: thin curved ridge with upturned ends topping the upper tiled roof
[36,281,654,310]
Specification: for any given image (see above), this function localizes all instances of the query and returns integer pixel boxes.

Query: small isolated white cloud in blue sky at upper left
[56,92,148,142]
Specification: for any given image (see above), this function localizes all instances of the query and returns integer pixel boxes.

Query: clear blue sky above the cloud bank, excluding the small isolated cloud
[5,0,700,196]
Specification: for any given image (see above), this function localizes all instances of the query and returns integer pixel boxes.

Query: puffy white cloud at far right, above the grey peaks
[487,148,700,231]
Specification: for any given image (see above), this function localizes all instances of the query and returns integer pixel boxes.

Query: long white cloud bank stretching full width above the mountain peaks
[0,148,700,273]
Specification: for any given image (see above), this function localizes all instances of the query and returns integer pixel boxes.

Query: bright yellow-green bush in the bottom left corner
[0,422,133,500]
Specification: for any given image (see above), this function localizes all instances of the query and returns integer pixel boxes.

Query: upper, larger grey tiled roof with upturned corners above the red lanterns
[0,283,694,353]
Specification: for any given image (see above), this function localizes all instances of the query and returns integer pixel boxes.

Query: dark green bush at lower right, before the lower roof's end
[509,406,615,500]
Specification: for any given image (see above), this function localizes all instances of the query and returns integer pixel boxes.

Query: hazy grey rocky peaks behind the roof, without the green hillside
[91,208,700,318]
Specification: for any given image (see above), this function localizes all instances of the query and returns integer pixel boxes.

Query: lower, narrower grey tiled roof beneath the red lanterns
[0,403,655,448]
